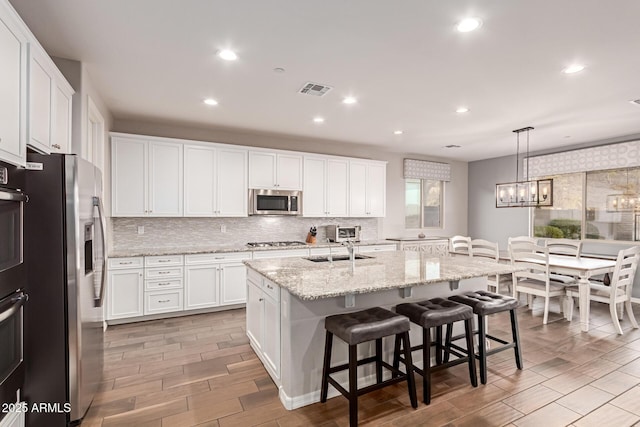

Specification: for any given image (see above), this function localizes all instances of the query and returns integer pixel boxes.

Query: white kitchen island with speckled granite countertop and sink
[244,251,513,409]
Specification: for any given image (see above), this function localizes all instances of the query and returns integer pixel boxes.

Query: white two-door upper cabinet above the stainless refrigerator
[27,44,73,154]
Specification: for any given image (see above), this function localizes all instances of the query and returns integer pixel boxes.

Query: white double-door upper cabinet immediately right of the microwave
[302,156,349,217]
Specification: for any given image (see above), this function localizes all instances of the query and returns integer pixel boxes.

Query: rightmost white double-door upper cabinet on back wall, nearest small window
[349,160,386,217]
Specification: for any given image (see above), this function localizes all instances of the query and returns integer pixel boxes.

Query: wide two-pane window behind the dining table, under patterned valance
[533,168,640,241]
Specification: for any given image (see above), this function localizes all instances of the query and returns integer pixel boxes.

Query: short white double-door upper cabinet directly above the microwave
[249,151,302,190]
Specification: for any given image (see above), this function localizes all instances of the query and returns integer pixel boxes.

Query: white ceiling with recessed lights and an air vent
[12,0,640,161]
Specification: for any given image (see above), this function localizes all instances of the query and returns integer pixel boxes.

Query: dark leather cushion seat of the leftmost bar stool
[324,307,411,345]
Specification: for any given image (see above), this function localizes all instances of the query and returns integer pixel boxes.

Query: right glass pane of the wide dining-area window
[585,168,640,240]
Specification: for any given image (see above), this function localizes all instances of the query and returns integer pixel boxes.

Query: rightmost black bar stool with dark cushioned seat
[445,291,522,384]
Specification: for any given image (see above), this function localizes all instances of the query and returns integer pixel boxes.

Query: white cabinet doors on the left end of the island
[247,271,280,378]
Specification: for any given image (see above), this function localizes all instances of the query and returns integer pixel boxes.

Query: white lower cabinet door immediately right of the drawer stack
[184,264,220,310]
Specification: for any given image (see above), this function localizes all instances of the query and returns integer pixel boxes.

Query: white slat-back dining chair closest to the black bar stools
[509,242,566,325]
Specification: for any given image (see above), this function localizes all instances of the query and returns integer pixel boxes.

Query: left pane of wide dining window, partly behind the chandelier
[533,173,589,239]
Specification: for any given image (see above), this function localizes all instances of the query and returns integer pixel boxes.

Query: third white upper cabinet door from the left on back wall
[184,145,216,216]
